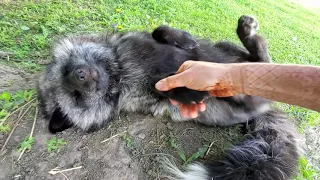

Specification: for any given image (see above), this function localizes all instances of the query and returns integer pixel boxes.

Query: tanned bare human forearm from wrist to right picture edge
[232,63,320,112]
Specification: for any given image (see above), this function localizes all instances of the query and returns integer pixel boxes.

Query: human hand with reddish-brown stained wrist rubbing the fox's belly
[156,61,240,118]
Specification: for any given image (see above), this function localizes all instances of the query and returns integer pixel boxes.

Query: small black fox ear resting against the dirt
[49,108,72,133]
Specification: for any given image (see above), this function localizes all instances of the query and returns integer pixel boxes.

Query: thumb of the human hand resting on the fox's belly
[155,73,186,91]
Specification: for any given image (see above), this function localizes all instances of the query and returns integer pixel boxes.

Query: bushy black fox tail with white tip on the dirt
[165,110,300,180]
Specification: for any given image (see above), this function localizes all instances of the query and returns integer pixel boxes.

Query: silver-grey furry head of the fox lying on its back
[38,36,118,132]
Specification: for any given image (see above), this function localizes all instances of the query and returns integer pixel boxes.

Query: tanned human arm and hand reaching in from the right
[156,61,320,112]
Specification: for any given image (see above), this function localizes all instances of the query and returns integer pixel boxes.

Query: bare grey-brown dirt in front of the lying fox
[0,66,245,180]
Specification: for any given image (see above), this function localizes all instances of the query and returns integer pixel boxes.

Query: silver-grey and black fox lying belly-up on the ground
[37,15,299,180]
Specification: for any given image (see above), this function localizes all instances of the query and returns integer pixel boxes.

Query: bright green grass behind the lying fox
[0,0,320,179]
